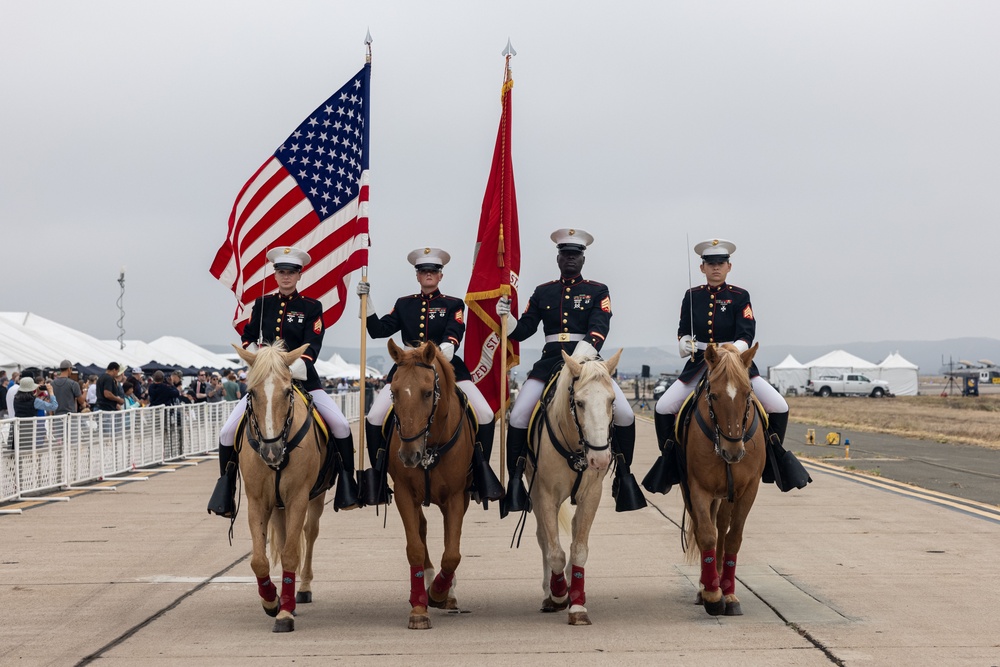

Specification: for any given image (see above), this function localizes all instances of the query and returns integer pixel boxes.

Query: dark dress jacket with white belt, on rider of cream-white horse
[508,276,611,382]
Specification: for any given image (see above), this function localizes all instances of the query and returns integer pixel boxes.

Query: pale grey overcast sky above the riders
[0,0,1000,356]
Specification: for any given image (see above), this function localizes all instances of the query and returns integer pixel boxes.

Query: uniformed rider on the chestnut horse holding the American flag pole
[358,248,499,500]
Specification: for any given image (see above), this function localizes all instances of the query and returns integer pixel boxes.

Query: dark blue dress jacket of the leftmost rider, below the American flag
[241,291,325,391]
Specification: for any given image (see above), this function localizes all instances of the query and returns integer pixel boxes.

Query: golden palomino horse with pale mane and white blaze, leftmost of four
[233,341,327,632]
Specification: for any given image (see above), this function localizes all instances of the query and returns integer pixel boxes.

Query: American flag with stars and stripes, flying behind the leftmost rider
[210,64,371,333]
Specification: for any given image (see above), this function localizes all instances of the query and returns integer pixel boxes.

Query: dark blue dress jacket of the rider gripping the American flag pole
[365,290,472,382]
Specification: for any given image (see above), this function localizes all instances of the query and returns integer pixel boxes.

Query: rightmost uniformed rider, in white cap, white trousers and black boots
[646,239,812,493]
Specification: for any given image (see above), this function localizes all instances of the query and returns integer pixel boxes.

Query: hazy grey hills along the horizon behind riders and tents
[203,338,1000,378]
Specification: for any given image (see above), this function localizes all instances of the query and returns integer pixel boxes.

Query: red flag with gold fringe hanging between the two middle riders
[463,47,521,415]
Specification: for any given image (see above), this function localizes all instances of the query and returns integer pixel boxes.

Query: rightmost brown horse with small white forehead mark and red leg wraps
[681,343,767,616]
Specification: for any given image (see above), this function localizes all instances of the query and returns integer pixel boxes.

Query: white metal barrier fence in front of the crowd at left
[0,392,360,511]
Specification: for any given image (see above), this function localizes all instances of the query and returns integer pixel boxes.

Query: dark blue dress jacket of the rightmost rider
[677,283,760,382]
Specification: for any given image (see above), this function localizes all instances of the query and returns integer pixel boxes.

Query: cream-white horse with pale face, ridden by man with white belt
[525,346,622,625]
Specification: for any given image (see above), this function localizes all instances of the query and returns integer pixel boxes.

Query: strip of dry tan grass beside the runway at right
[788,394,1000,449]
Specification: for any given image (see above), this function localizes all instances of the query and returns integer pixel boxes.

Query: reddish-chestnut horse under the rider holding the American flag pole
[388,340,476,630]
